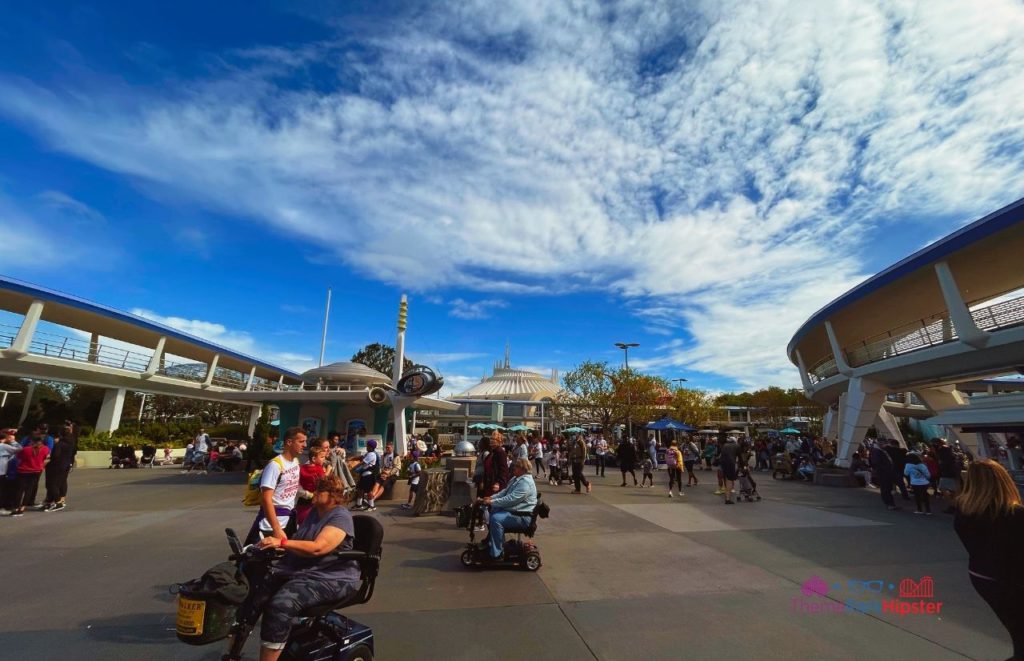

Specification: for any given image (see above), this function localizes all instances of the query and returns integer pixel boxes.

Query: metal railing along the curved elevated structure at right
[808,296,1024,384]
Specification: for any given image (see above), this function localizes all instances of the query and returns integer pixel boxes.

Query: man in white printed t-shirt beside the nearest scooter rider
[246,427,306,544]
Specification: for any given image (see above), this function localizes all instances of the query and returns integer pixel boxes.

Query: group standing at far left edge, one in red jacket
[0,422,78,517]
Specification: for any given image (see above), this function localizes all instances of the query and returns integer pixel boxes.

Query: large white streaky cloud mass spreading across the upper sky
[0,0,1024,384]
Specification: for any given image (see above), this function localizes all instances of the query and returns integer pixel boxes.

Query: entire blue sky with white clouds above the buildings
[0,0,1024,391]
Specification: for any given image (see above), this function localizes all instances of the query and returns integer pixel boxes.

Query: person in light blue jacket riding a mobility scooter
[456,459,551,572]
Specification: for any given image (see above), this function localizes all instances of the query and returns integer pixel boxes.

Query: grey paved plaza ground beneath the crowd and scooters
[0,469,1011,661]
